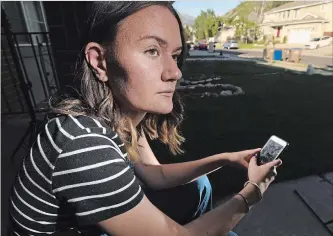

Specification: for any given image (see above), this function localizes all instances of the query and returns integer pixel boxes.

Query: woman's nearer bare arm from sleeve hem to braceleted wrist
[99,185,259,236]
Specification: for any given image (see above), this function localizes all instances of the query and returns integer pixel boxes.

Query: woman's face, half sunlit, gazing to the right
[109,6,182,114]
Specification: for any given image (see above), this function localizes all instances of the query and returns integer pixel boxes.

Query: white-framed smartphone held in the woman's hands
[257,135,289,165]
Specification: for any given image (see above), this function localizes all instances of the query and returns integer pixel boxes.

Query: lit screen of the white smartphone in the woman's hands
[258,138,286,164]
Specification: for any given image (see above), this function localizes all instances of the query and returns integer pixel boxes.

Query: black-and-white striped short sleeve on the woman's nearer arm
[52,134,143,226]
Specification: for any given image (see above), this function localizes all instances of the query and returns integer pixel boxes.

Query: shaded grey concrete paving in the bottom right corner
[214,172,333,236]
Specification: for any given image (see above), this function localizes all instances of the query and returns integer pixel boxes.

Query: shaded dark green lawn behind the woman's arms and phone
[153,61,333,195]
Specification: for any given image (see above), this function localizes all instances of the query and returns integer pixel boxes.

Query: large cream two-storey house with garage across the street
[260,0,333,43]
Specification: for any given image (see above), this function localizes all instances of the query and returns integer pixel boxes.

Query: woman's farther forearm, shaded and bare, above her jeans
[135,154,227,190]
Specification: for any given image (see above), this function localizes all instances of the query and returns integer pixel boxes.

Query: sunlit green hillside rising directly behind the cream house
[224,1,291,21]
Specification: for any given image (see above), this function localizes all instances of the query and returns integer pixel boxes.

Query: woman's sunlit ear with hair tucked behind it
[84,42,108,82]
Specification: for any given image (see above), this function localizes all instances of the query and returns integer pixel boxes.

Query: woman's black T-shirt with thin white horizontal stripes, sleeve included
[10,115,143,235]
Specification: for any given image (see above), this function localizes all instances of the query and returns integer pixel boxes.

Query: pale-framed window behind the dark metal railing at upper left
[1,1,48,45]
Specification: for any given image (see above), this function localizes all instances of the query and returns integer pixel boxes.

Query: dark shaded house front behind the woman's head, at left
[1,1,91,114]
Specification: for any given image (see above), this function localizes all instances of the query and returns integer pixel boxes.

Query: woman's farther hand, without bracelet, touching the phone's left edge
[227,148,261,169]
